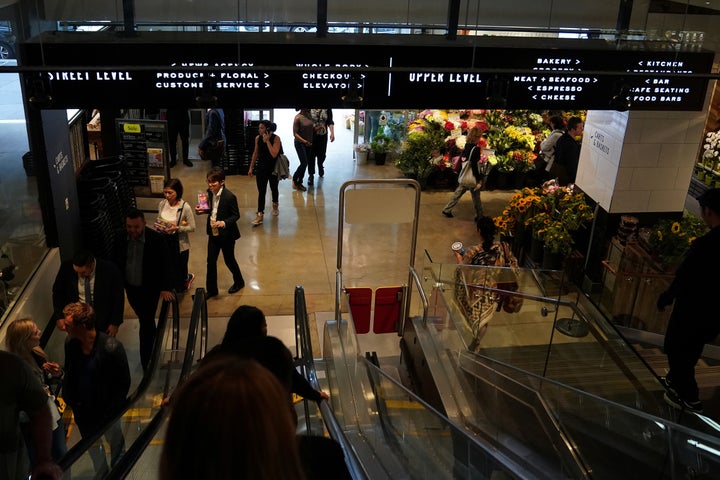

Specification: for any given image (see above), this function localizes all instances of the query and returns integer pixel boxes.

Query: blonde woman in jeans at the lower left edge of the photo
[5,318,67,465]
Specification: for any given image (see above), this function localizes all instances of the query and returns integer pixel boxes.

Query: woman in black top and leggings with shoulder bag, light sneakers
[248,120,282,225]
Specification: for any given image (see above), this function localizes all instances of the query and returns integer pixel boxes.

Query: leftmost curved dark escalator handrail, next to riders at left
[58,297,180,471]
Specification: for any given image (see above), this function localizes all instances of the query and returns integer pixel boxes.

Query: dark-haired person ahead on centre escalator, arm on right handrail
[206,305,330,402]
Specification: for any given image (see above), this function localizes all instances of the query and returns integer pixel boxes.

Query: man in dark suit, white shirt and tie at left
[53,250,125,337]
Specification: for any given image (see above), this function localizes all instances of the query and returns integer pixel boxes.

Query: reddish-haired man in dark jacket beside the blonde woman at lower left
[63,302,130,478]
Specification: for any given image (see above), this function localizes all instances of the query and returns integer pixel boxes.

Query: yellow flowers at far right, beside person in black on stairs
[648,211,707,268]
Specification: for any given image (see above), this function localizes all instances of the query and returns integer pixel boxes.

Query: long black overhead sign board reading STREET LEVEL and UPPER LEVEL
[22,32,713,110]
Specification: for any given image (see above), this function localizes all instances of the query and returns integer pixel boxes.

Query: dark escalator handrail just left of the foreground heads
[105,288,207,480]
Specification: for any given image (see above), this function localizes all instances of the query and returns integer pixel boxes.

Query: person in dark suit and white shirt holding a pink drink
[196,167,245,298]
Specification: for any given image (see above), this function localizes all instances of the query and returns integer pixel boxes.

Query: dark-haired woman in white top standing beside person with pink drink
[155,178,195,293]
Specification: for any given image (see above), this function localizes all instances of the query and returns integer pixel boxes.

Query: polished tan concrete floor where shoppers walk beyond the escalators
[162,110,513,326]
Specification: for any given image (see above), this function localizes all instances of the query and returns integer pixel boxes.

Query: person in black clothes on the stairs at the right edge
[657,188,720,413]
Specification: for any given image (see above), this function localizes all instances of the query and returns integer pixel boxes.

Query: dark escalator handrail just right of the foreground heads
[295,286,370,480]
